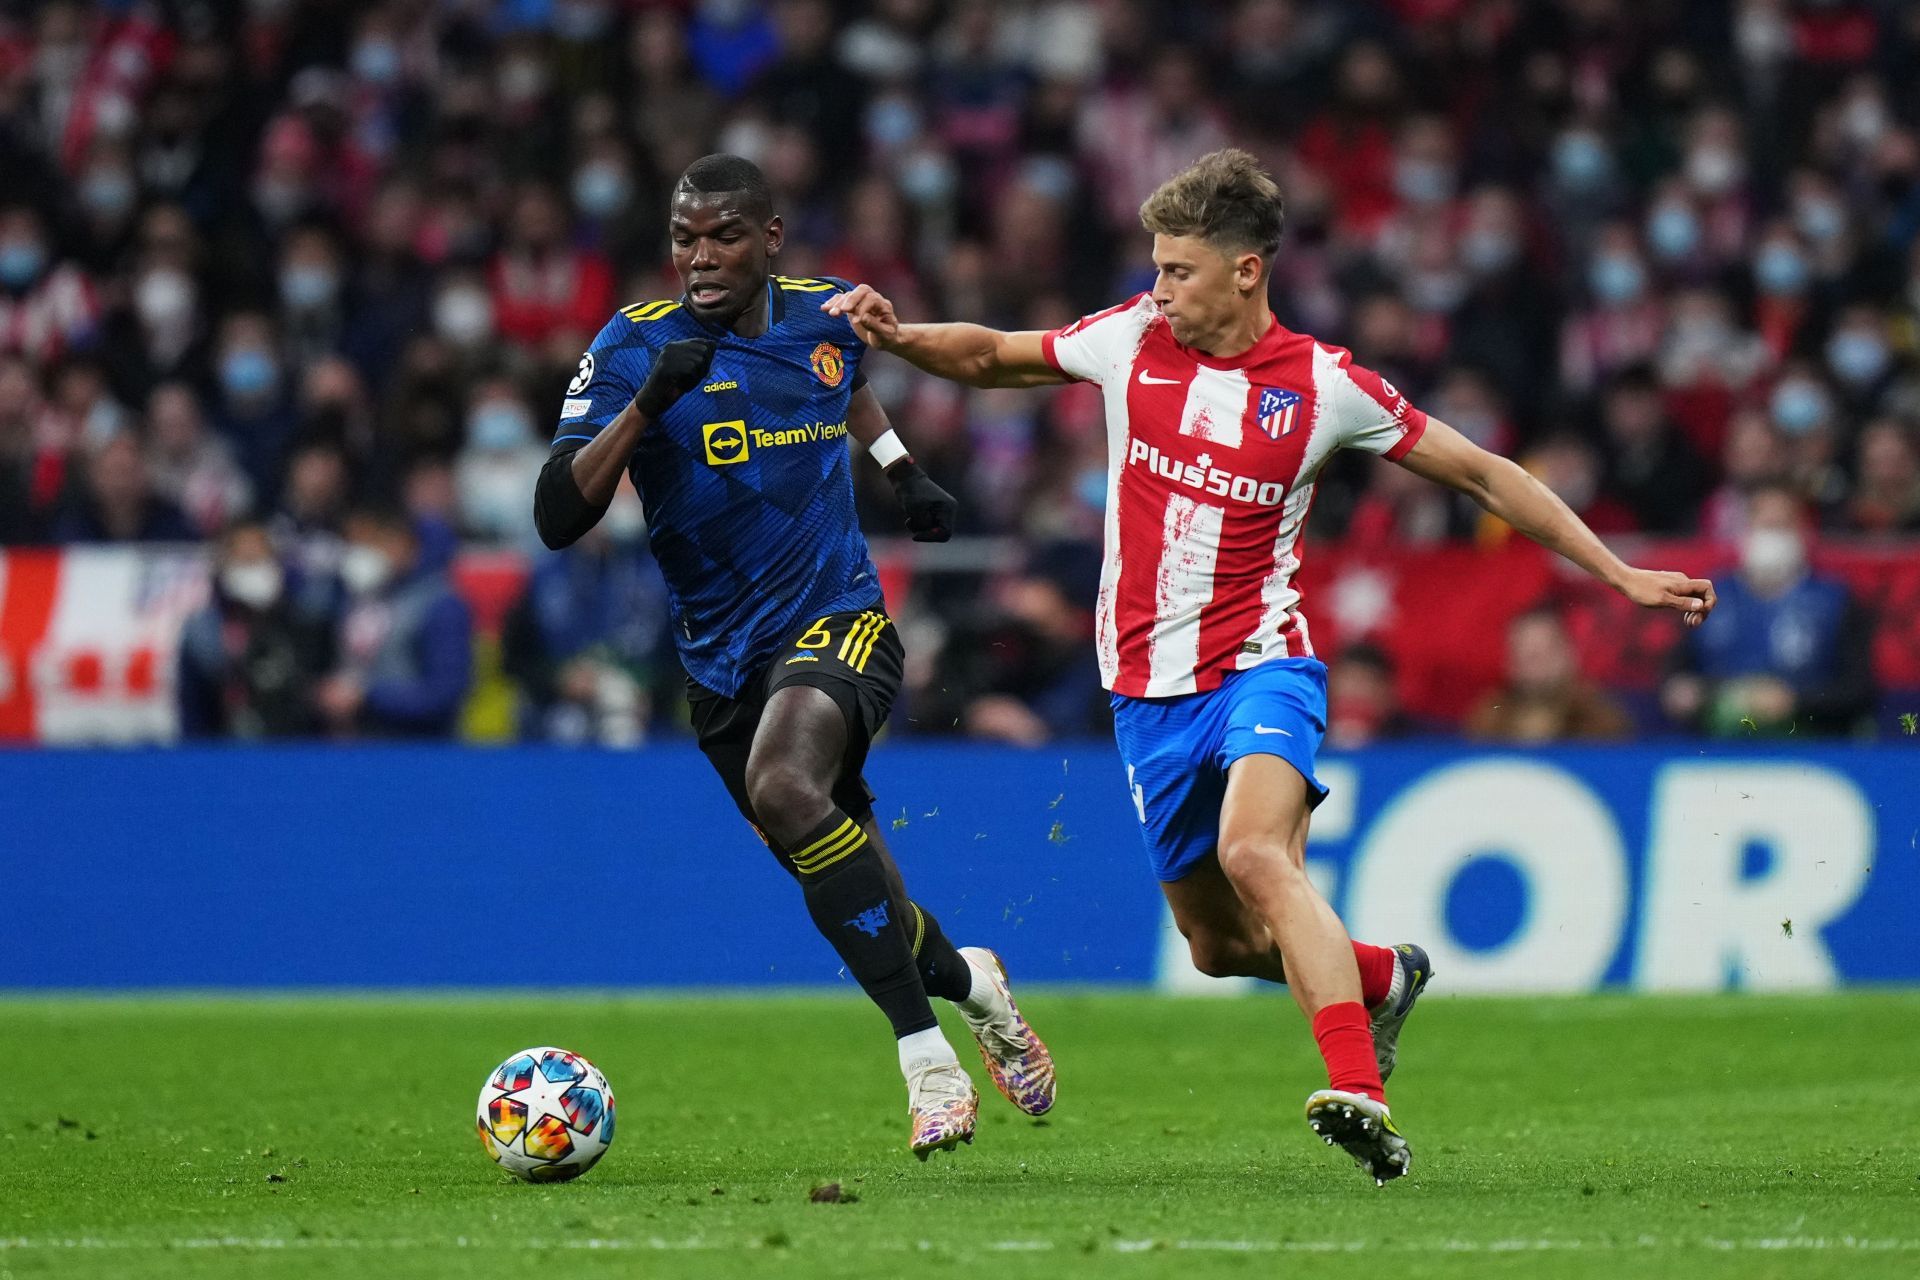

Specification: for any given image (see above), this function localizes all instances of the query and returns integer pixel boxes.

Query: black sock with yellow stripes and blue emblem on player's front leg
[793,808,940,1036]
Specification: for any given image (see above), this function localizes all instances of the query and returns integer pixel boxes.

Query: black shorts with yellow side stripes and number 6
[687,608,906,839]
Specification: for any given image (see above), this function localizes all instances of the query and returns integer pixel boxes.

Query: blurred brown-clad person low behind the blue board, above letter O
[1467,608,1634,743]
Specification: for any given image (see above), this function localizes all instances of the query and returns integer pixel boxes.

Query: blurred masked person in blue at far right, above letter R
[1661,486,1874,737]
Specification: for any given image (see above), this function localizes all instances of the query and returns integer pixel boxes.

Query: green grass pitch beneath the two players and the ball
[0,975,1920,1280]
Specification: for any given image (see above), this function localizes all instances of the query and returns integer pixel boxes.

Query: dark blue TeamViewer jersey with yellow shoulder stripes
[553,276,879,697]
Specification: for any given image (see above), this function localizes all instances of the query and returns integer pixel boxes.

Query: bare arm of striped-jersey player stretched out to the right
[1400,418,1715,626]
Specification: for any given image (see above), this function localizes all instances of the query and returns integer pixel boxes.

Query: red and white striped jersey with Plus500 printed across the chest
[1043,294,1427,699]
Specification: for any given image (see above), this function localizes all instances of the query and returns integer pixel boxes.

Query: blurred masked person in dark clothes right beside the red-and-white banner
[175,520,332,739]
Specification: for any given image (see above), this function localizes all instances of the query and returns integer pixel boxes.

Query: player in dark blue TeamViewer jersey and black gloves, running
[534,155,1054,1159]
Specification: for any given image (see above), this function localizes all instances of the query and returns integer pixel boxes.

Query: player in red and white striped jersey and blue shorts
[826,150,1715,1182]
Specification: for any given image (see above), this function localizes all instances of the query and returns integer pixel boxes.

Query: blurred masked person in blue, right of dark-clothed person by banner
[315,507,472,737]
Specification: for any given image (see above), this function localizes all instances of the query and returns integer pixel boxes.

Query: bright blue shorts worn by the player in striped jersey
[1114,658,1327,881]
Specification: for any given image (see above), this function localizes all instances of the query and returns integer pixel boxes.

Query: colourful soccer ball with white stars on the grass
[476,1046,612,1182]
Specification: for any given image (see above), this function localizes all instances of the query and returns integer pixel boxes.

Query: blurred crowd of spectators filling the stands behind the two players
[0,0,1920,741]
